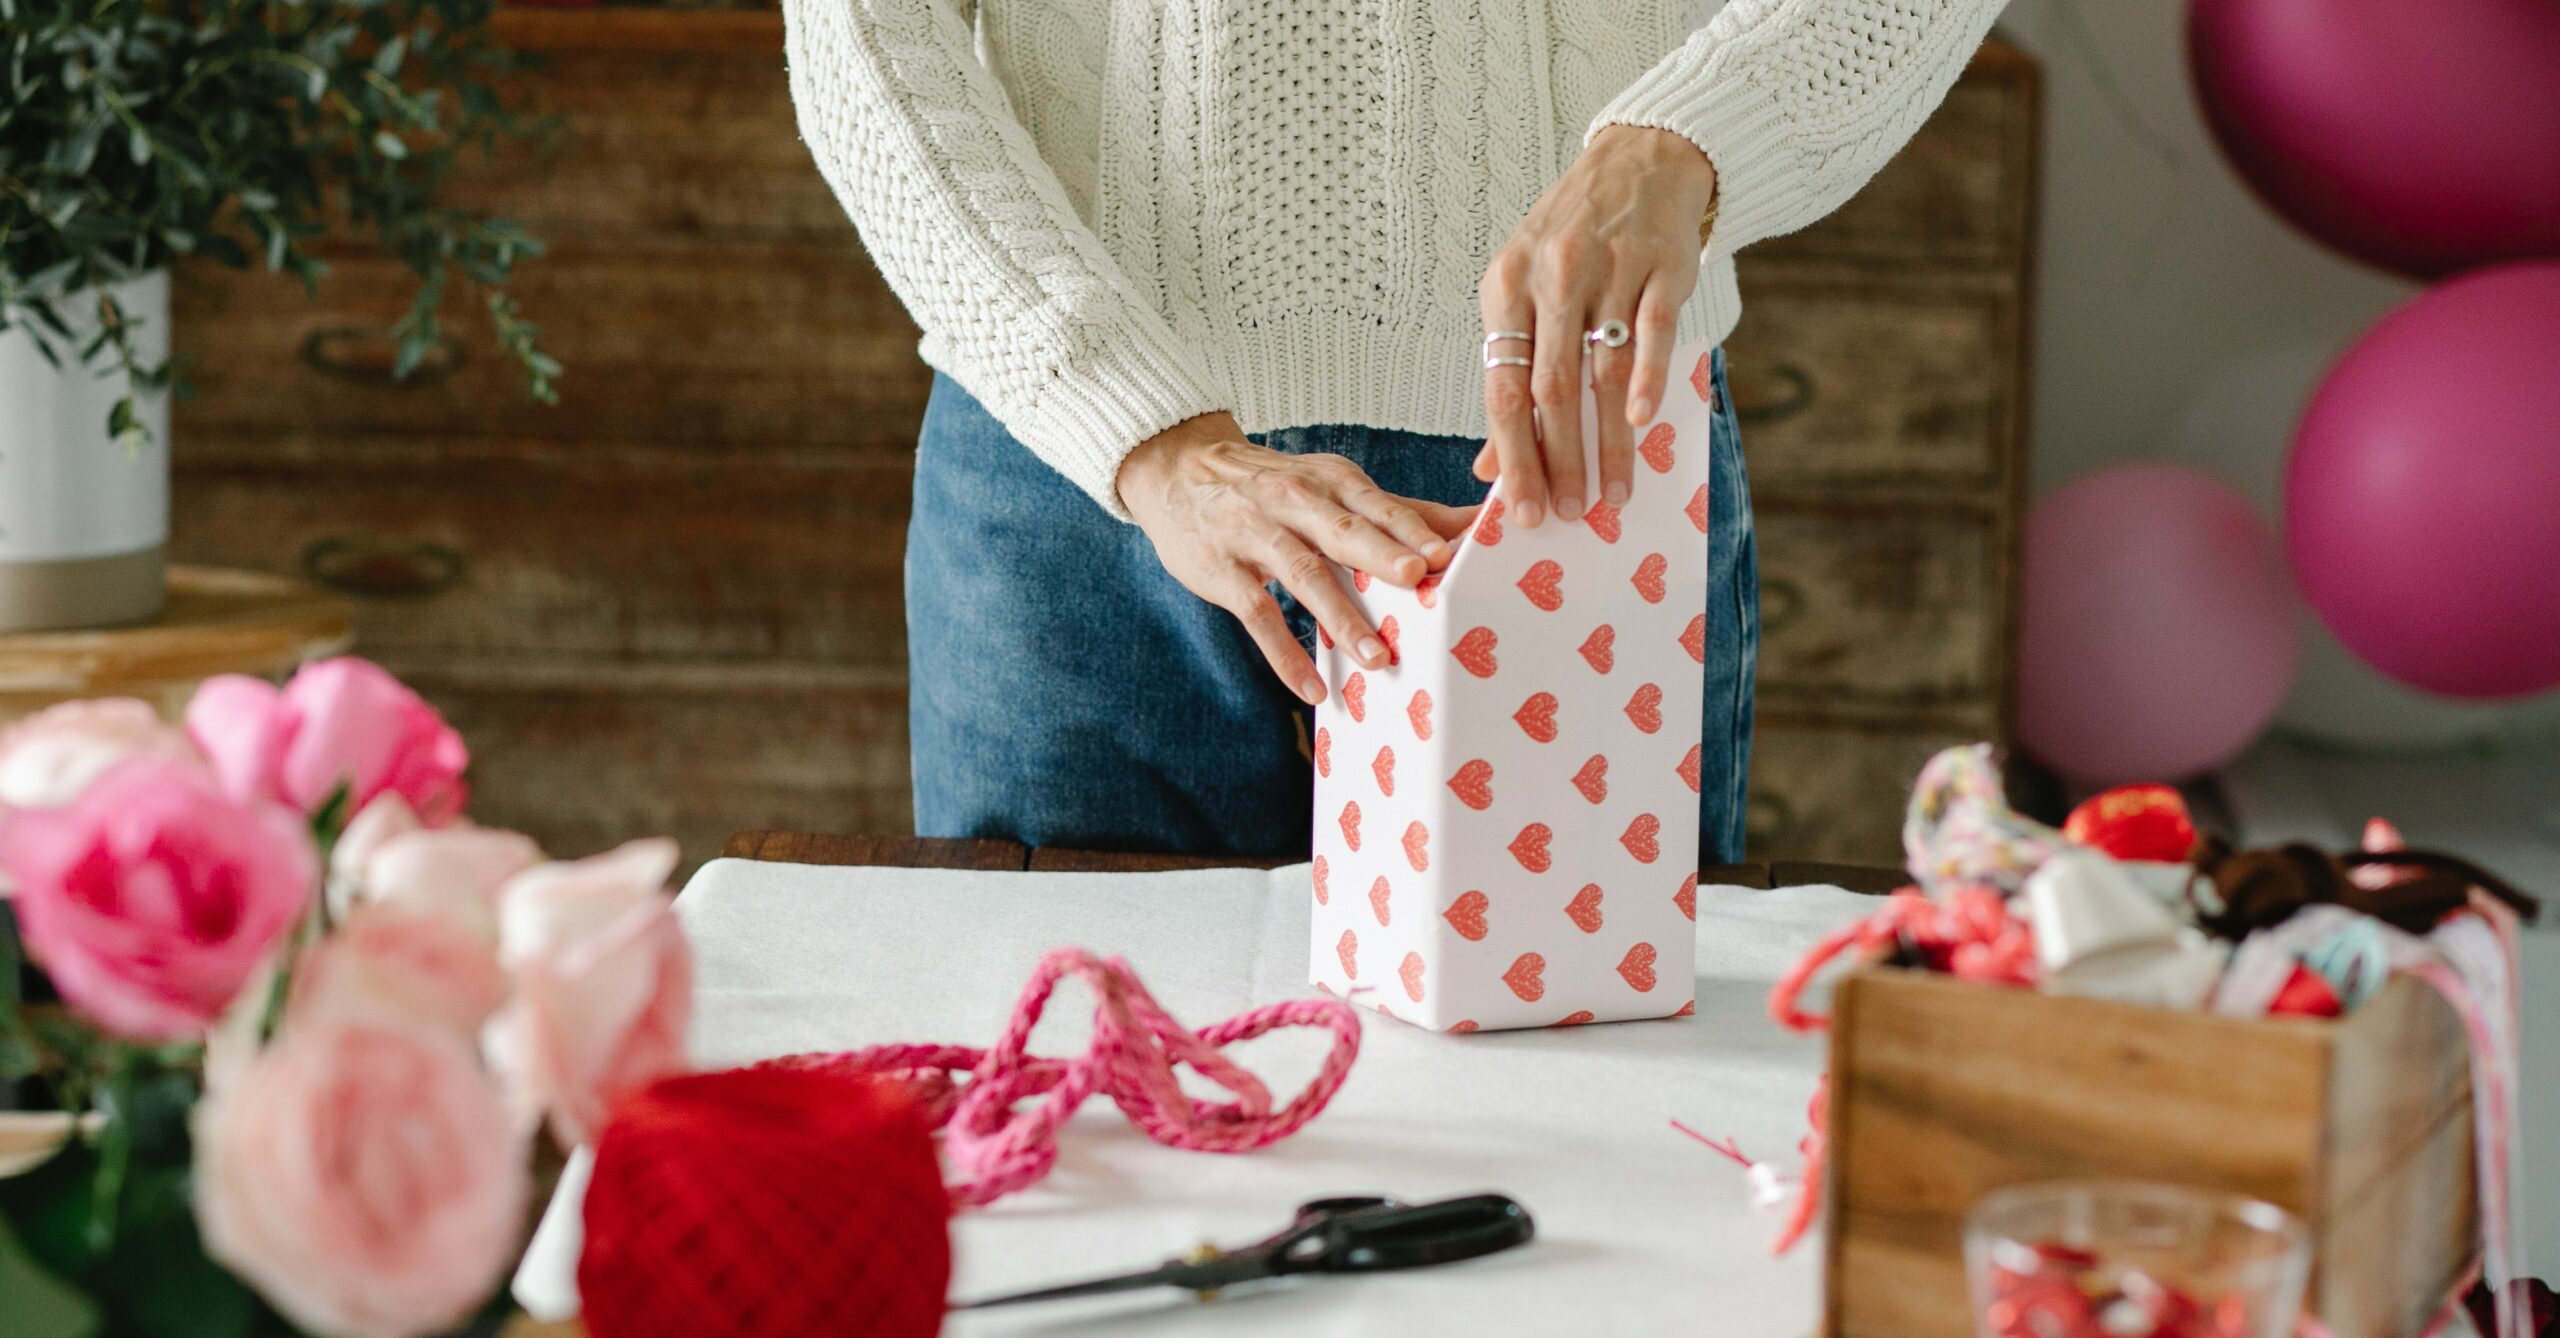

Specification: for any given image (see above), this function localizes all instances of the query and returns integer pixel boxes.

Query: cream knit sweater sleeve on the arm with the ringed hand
[1592,0,2007,253]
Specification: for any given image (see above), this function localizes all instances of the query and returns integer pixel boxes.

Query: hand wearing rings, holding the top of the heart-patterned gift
[1475,125,1715,527]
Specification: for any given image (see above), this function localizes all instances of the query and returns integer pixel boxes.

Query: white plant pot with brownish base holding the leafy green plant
[0,271,169,632]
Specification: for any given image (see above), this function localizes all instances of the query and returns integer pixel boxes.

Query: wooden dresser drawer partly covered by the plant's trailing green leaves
[174,243,932,463]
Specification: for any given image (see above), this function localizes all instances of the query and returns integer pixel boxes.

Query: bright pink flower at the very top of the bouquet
[187,655,471,826]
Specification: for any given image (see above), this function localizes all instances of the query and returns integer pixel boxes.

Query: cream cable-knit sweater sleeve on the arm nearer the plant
[783,0,1231,519]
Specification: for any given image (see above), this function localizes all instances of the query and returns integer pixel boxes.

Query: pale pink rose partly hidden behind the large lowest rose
[284,903,507,1039]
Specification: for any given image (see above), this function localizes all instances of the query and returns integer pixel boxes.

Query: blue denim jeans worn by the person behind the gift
[906,356,1759,862]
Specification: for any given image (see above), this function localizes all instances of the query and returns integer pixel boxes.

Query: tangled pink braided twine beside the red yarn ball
[768,947,1359,1208]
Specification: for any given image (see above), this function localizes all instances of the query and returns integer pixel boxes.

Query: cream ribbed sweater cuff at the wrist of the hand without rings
[1001,312,1234,519]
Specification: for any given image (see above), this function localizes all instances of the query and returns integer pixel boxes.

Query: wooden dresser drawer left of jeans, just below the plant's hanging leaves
[172,437,909,670]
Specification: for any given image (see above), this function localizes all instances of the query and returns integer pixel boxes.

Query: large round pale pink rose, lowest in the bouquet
[195,1016,527,1338]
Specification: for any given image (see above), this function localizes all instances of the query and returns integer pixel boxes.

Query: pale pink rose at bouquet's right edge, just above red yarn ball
[497,839,694,1146]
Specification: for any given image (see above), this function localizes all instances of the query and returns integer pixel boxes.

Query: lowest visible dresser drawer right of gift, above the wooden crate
[1743,716,1989,865]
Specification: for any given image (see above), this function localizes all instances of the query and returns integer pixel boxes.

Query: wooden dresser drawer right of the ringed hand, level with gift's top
[1728,277,2020,496]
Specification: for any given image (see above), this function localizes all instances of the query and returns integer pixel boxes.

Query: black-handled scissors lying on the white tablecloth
[952,1195,1536,1310]
